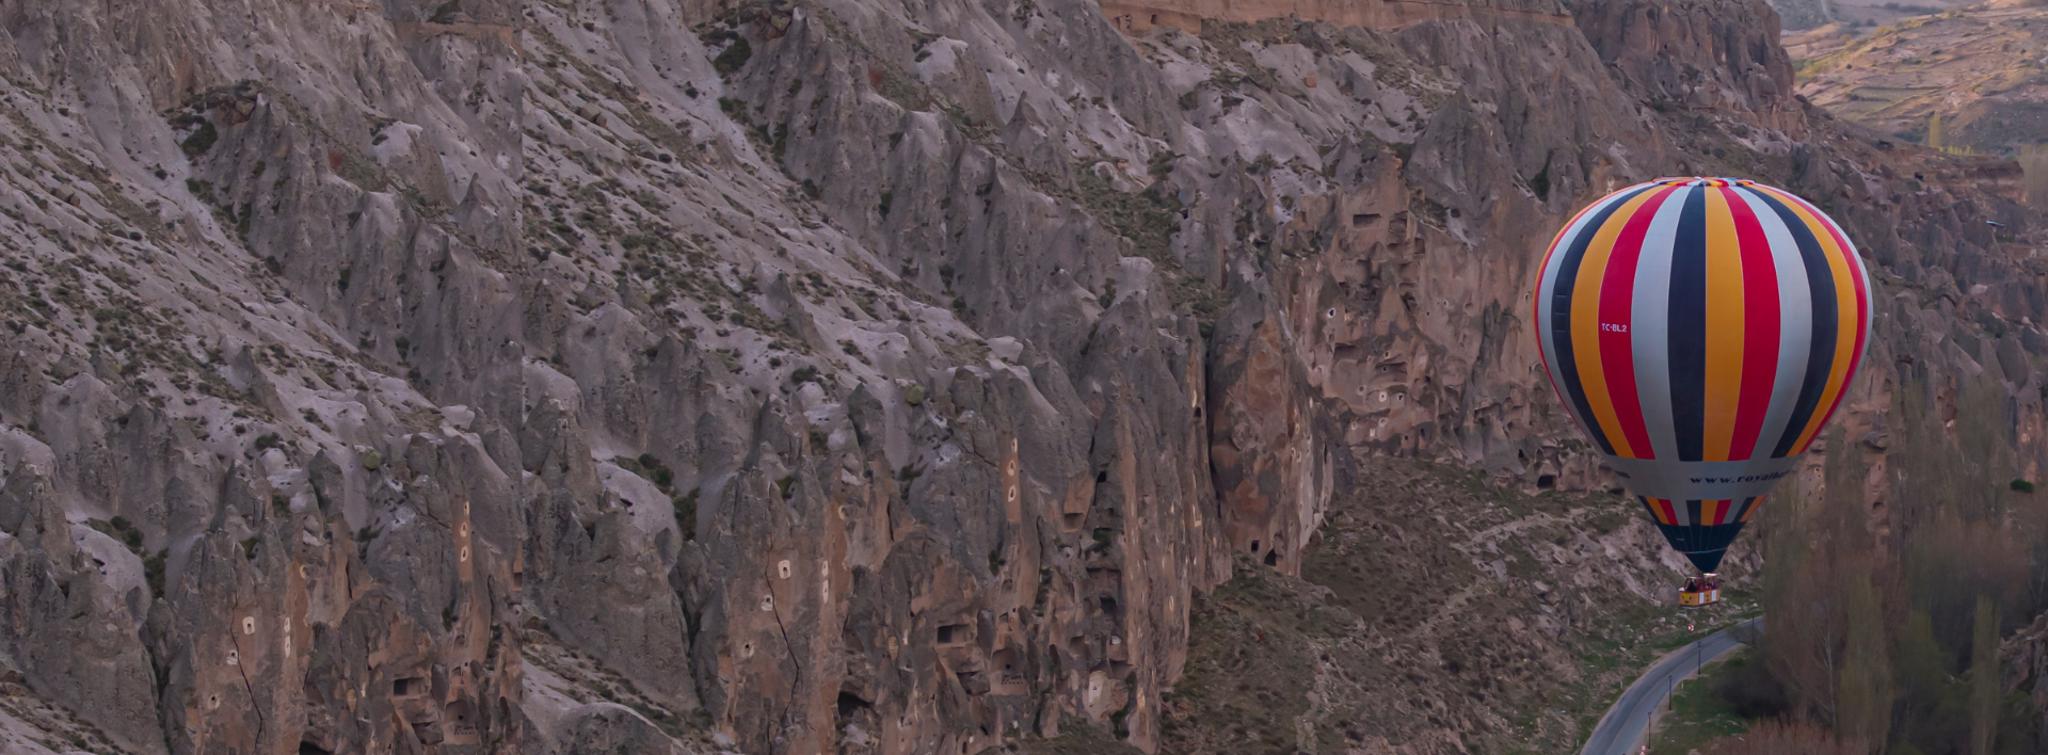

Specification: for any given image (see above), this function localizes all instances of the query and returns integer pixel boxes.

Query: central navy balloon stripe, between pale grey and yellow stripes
[1665,188,1706,460]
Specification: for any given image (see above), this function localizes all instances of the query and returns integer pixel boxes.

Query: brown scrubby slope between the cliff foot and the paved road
[1161,458,1755,753]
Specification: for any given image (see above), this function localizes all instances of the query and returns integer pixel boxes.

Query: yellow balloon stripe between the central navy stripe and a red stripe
[1679,190,1743,460]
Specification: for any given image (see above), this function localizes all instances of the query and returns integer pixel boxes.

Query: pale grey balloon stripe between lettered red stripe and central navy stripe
[1628,186,1702,460]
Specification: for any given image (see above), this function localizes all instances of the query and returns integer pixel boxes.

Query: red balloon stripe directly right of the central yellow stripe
[1714,188,1782,460]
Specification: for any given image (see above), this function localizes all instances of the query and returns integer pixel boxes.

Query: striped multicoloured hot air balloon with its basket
[1532,178,1870,606]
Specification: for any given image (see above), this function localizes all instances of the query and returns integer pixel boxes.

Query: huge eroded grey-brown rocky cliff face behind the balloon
[0,0,2048,753]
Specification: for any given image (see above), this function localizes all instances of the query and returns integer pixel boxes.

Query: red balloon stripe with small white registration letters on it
[1599,186,1677,458]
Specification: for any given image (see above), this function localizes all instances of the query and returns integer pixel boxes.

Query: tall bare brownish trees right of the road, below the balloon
[1765,374,2048,753]
